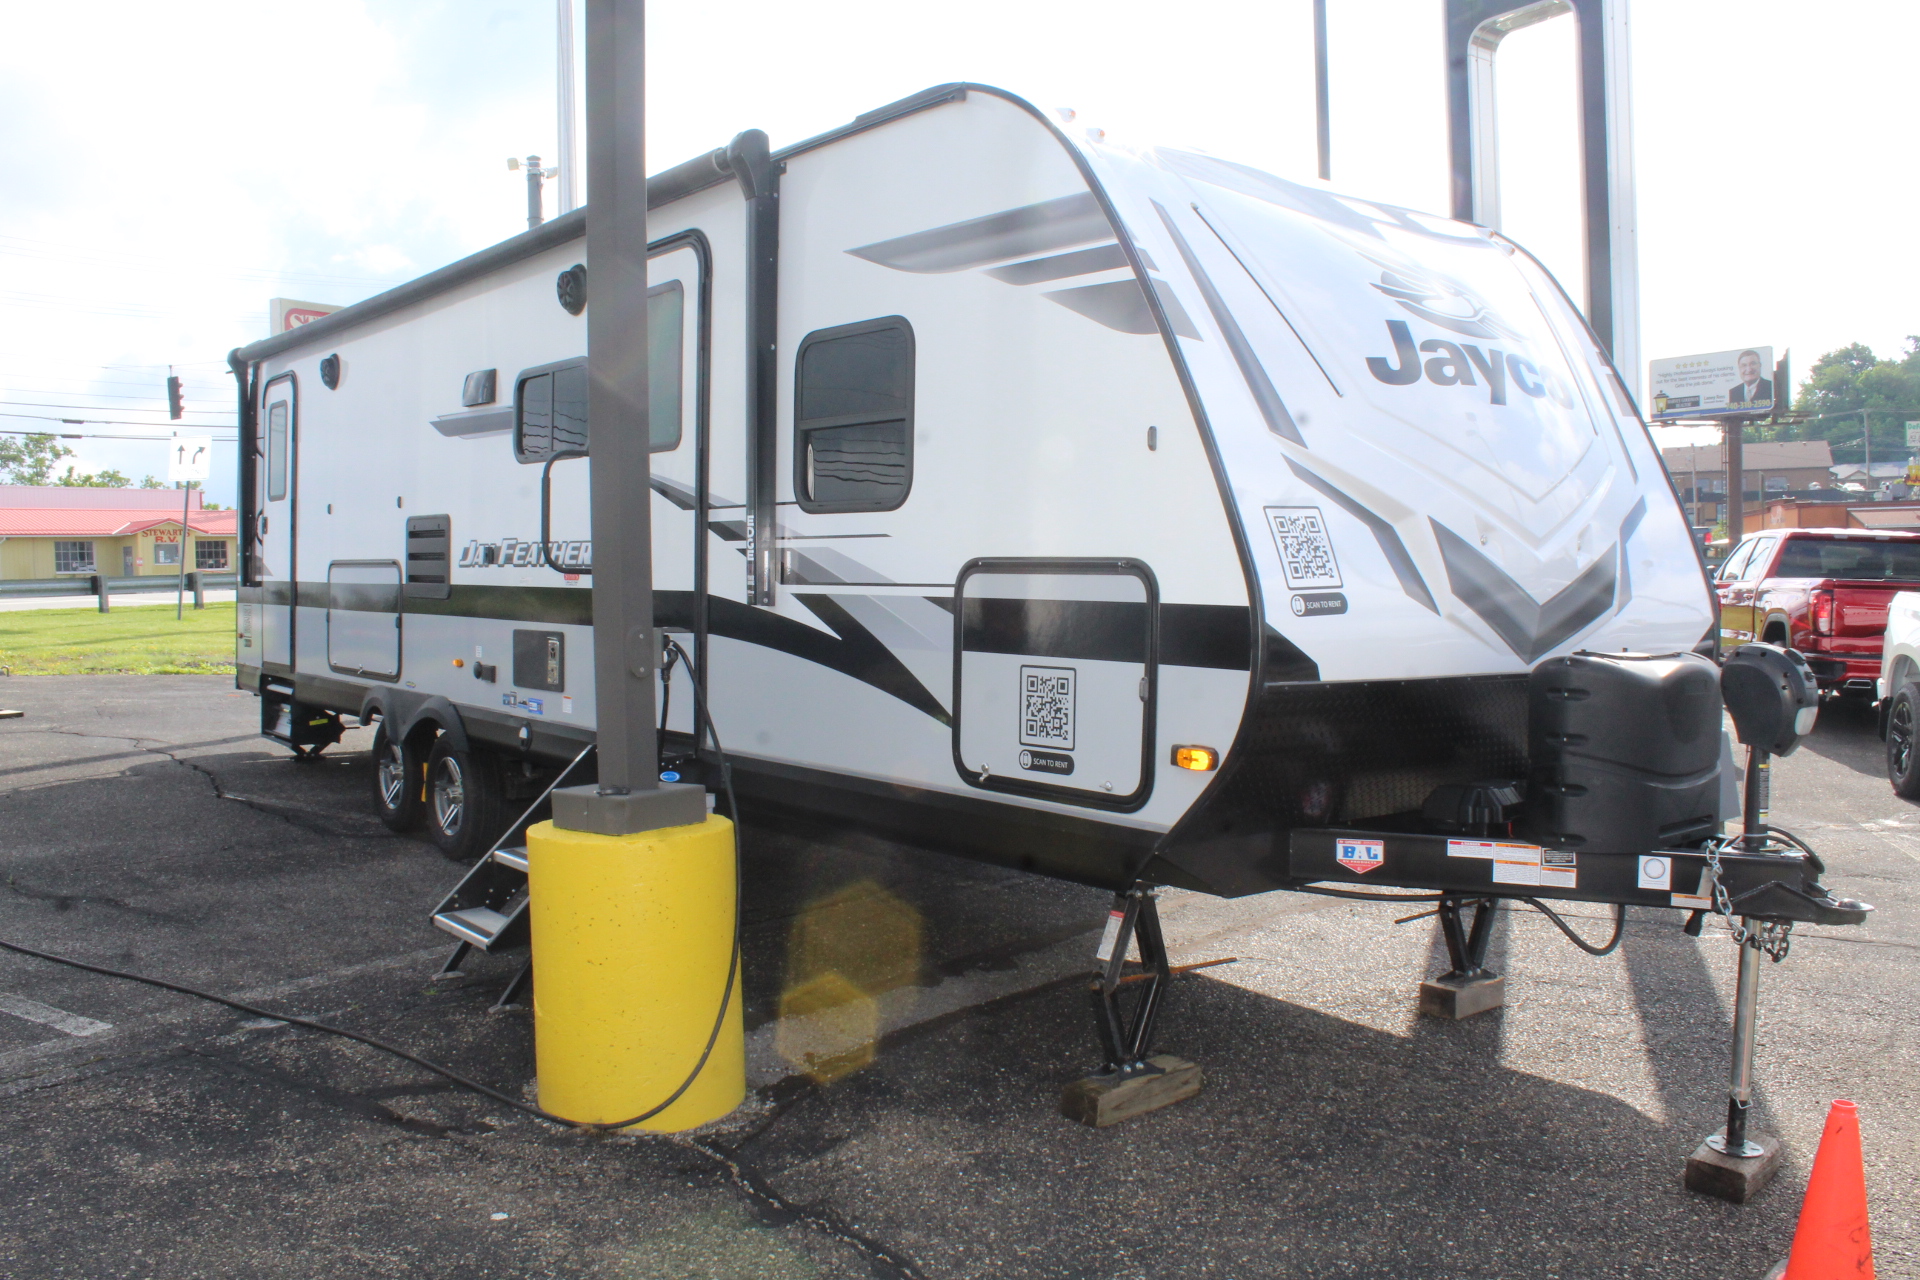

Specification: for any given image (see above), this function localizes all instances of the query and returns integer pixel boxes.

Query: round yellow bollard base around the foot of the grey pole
[526,816,747,1132]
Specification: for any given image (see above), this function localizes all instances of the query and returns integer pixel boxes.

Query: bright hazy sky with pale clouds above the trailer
[0,0,1920,503]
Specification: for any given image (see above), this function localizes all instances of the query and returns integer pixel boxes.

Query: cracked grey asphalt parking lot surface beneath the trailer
[0,677,1920,1280]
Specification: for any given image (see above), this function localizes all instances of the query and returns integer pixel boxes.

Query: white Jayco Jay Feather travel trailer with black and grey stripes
[232,84,1837,990]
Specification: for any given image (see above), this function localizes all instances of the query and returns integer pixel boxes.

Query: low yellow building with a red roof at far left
[0,484,240,578]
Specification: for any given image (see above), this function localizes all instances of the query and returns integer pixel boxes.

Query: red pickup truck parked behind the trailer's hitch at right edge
[1713,530,1920,697]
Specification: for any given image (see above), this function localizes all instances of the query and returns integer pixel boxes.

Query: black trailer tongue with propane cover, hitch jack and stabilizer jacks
[1090,645,1872,1201]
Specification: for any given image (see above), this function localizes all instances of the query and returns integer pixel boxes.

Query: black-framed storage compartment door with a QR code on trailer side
[954,560,1160,810]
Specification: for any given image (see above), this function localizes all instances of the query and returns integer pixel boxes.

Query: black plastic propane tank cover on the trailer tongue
[1519,652,1720,854]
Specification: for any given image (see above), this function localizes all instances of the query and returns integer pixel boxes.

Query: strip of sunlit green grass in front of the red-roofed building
[0,601,234,676]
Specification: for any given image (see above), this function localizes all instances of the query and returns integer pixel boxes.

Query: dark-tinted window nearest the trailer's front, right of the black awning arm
[793,315,914,510]
